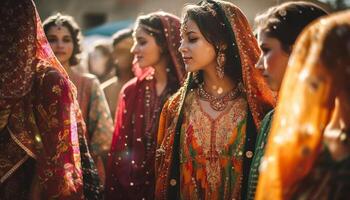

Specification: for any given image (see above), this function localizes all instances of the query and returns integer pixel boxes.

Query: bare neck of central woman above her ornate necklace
[203,63,236,96]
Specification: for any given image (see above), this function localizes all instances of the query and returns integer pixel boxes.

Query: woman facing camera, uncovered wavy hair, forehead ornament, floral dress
[43,14,113,186]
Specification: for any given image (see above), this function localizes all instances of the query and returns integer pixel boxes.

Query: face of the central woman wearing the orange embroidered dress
[179,19,217,72]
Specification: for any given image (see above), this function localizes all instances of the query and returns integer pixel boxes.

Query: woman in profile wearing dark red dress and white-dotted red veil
[106,12,184,199]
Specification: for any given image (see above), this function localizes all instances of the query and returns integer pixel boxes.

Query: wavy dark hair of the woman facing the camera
[43,13,82,65]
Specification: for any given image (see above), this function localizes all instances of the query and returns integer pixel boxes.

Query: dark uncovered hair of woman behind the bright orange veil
[255,1,327,53]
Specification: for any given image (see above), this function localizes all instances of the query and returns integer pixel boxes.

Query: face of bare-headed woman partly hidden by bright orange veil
[255,30,289,91]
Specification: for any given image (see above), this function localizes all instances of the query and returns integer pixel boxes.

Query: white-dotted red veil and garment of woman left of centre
[106,12,184,199]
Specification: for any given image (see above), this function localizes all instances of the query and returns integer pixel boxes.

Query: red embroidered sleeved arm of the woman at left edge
[34,70,84,199]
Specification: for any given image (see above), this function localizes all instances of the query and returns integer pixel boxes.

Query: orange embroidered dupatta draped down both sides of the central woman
[156,1,275,199]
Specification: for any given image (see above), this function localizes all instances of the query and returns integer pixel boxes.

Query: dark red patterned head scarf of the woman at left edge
[0,0,68,101]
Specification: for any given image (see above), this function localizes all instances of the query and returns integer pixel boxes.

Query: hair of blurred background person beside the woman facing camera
[88,42,114,79]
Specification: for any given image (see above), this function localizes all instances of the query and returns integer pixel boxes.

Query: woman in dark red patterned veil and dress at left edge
[0,0,85,200]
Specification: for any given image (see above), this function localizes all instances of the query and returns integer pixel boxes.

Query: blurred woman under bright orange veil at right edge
[257,11,350,200]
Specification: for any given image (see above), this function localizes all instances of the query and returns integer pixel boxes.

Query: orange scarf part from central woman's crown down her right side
[189,0,275,128]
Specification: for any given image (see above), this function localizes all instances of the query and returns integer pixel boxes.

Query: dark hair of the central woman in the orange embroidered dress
[182,2,242,85]
